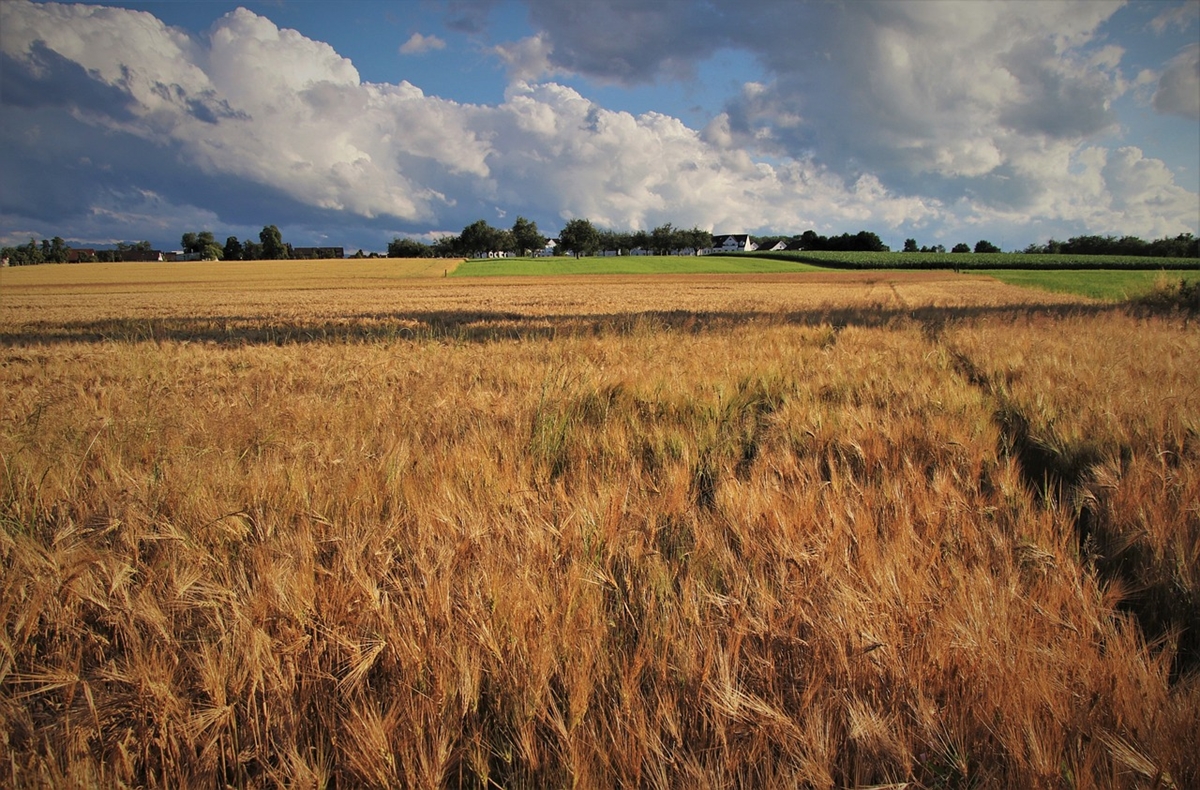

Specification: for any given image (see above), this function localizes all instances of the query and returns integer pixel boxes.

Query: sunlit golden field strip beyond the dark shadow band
[0,262,1096,335]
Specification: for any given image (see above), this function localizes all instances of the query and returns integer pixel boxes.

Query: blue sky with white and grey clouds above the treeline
[0,0,1200,251]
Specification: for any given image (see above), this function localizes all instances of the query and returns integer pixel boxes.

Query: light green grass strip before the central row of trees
[450,255,821,277]
